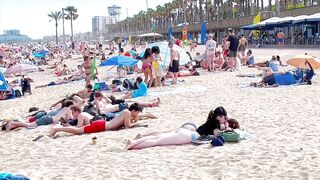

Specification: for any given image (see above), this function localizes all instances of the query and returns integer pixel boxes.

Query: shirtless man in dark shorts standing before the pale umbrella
[168,42,180,84]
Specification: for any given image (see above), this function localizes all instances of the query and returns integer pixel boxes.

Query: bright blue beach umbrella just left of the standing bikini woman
[100,56,138,66]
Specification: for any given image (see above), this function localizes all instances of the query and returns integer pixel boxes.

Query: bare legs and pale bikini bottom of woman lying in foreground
[125,123,200,150]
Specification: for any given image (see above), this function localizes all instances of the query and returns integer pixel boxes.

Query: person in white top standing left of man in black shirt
[206,34,217,71]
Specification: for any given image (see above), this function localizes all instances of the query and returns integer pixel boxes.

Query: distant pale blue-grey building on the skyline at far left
[0,29,31,43]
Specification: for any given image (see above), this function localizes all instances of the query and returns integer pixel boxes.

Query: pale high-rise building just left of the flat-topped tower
[92,16,107,39]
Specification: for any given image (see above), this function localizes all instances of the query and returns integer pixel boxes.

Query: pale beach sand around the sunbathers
[0,47,320,179]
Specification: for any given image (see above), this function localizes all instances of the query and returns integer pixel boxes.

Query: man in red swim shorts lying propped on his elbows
[50,103,142,137]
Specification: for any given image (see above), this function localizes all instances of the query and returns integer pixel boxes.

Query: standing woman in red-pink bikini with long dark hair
[142,48,153,87]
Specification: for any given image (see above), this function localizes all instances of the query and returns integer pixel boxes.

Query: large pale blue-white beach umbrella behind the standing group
[145,41,190,66]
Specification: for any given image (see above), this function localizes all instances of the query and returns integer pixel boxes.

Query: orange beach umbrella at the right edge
[287,54,320,69]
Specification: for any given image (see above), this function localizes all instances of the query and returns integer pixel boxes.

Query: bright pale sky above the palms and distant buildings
[0,0,171,38]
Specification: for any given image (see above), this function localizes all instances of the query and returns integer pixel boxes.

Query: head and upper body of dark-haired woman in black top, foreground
[197,106,229,136]
